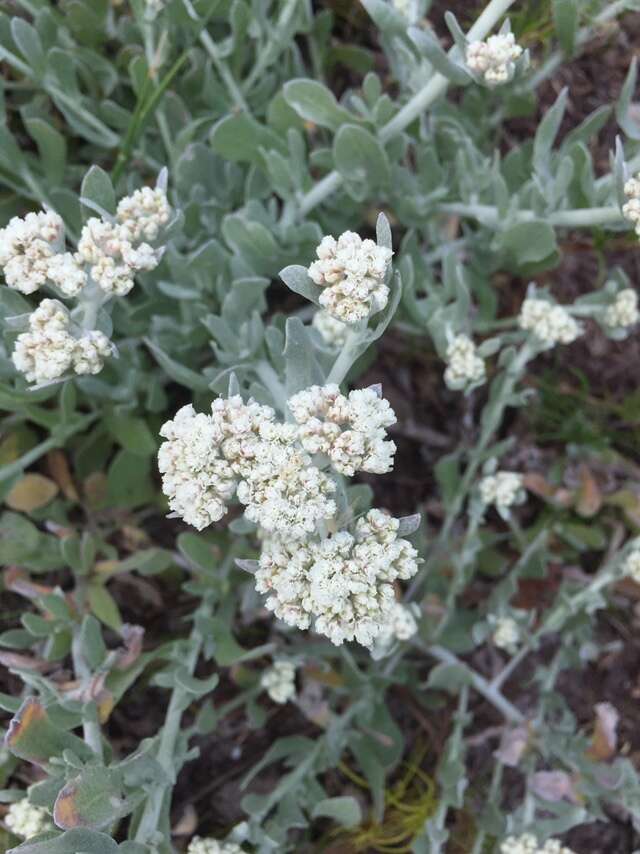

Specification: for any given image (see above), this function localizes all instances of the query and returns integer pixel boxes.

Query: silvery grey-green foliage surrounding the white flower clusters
[0,0,640,854]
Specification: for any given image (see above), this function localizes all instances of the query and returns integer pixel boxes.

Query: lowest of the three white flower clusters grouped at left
[12,299,113,383]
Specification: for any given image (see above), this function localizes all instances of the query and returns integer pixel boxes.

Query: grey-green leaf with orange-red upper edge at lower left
[4,697,94,765]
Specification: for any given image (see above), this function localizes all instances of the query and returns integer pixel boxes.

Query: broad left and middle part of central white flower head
[158,396,336,538]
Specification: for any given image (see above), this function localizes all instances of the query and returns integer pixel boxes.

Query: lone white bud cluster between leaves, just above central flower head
[309,231,393,323]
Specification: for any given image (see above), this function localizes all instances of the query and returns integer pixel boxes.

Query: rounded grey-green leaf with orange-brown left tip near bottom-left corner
[53,767,129,830]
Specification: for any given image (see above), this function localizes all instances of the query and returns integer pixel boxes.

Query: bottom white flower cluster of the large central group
[255,510,418,648]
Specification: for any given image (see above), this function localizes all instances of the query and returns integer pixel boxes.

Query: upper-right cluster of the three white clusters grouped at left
[78,187,171,296]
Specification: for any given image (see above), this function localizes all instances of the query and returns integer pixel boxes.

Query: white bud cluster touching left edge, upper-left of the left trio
[0,211,86,296]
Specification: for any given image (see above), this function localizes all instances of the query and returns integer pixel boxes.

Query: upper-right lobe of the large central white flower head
[288,384,396,477]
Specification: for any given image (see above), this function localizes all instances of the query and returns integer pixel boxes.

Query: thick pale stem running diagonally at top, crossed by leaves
[299,0,515,217]
